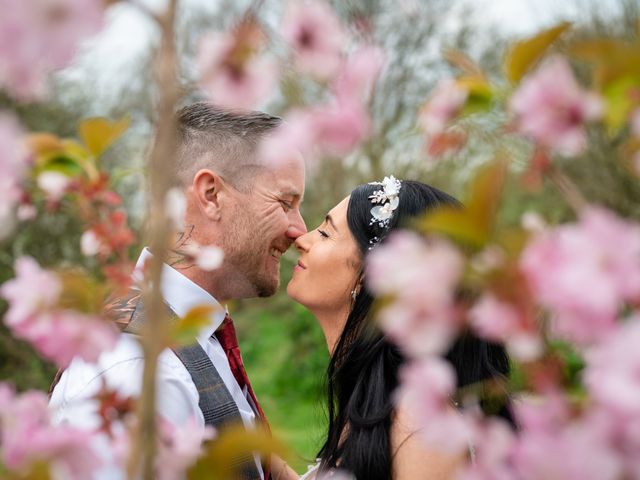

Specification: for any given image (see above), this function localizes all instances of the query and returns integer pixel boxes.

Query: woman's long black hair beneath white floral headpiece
[319,180,509,480]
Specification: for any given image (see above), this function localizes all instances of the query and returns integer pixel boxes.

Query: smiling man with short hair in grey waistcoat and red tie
[51,103,306,479]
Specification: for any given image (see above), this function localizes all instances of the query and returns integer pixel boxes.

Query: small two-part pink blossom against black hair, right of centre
[469,293,543,361]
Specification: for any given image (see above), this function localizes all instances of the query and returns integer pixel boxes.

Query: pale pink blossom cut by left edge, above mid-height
[0,110,27,234]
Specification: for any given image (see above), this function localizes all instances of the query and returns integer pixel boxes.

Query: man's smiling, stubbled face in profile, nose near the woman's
[222,159,307,297]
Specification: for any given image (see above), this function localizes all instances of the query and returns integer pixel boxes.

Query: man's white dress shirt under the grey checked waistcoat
[49,248,263,479]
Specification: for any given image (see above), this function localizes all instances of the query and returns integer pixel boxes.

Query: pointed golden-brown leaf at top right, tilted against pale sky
[505,22,571,83]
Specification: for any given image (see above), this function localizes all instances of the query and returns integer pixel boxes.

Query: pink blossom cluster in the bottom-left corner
[0,383,100,480]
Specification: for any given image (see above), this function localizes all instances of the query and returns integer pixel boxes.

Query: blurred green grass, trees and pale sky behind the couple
[0,0,640,469]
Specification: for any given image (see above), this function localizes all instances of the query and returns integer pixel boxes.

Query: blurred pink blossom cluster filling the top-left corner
[0,0,103,101]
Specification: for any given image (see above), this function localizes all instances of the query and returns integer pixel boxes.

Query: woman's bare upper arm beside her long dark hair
[391,399,464,480]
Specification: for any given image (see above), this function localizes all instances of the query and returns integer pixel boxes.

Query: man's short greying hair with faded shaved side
[174,102,282,192]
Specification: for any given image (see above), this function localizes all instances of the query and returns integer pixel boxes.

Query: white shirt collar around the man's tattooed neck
[133,247,226,341]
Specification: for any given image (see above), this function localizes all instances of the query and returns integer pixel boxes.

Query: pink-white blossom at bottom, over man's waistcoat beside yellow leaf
[156,417,215,480]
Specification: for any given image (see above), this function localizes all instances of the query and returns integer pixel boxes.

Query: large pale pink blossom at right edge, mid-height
[520,207,640,345]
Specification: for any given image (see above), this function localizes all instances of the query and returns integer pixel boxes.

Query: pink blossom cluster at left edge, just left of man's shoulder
[0,257,118,367]
